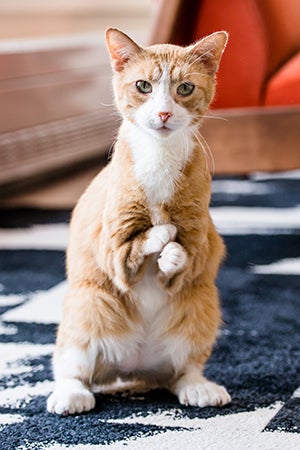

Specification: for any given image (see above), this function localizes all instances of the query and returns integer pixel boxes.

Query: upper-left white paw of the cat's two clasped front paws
[144,223,177,255]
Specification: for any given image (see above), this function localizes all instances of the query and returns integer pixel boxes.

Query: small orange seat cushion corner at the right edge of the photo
[265,52,300,106]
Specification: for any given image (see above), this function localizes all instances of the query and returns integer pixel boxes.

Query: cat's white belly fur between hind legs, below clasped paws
[113,257,188,375]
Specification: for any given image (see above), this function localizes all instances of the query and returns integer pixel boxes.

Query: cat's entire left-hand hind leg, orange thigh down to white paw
[47,284,130,415]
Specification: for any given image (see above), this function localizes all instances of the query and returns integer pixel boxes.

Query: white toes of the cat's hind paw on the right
[177,381,231,407]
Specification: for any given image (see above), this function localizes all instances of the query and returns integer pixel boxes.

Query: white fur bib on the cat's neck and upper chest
[119,121,195,205]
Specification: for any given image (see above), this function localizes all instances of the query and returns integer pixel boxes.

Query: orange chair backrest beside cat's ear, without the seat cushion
[194,0,267,108]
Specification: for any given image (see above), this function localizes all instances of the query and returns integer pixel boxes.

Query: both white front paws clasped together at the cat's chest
[144,224,187,277]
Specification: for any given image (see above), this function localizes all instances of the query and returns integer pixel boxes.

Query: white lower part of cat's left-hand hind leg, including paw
[47,346,95,415]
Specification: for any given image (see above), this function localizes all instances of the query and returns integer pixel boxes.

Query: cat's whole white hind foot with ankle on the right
[170,365,231,407]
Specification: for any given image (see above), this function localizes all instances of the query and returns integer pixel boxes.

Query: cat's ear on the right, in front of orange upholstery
[187,31,228,74]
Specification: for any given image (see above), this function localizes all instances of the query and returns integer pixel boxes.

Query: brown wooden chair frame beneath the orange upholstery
[202,106,300,174]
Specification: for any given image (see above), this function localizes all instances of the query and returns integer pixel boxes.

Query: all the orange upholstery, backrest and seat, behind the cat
[193,0,300,108]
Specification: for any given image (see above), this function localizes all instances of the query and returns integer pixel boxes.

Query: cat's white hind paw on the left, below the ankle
[47,382,96,416]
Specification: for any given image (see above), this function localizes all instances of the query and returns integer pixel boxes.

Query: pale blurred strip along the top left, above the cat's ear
[0,0,155,39]
